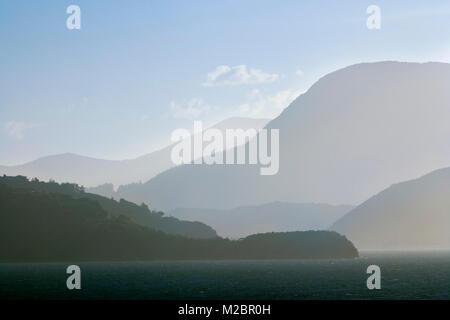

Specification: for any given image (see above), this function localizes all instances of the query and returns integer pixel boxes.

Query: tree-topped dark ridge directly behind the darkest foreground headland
[0,176,217,239]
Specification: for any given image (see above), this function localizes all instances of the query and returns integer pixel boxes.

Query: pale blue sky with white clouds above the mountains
[0,0,450,165]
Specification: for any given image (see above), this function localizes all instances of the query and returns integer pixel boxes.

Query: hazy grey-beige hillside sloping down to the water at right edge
[331,168,450,250]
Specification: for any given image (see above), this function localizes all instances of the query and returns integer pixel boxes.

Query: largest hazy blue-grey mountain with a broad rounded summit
[112,62,450,210]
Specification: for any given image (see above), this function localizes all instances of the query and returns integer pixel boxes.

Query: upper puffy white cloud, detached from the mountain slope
[203,64,280,87]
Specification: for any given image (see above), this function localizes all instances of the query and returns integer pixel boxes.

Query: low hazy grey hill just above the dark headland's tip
[167,202,353,239]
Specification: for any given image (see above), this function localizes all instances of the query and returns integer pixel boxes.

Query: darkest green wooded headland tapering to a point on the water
[0,178,358,262]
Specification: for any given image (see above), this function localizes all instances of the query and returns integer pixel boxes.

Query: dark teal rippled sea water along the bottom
[0,252,450,299]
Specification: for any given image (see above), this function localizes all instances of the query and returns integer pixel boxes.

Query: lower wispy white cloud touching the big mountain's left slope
[237,89,305,118]
